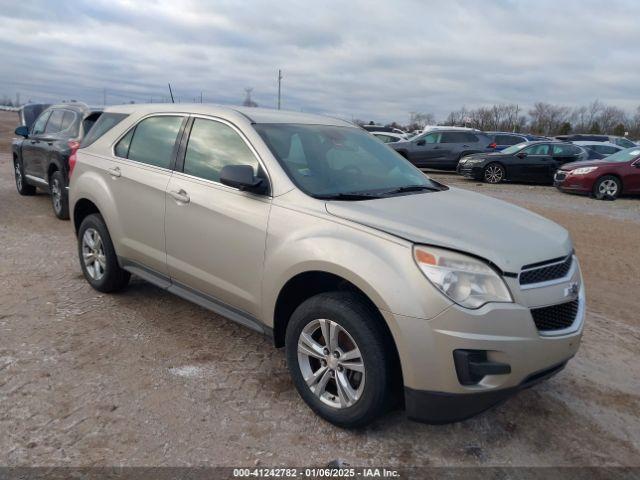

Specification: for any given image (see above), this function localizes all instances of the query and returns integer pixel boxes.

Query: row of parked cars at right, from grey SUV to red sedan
[365,126,640,199]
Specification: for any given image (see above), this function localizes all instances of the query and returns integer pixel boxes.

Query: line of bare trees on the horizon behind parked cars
[357,100,640,138]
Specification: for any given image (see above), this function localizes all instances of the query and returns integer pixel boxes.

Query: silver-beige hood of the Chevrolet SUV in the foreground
[326,188,572,273]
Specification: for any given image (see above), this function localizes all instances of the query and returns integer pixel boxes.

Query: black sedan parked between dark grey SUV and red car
[457,141,588,183]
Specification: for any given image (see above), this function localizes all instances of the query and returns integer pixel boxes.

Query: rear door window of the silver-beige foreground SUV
[115,115,184,168]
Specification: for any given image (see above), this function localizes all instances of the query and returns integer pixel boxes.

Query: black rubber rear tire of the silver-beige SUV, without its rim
[78,213,131,293]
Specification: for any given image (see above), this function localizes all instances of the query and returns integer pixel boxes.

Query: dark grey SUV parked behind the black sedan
[389,129,495,170]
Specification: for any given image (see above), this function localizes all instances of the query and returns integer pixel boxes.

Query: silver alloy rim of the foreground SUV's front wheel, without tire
[298,319,365,409]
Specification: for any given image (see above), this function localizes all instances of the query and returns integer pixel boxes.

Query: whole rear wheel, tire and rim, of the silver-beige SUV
[78,213,131,293]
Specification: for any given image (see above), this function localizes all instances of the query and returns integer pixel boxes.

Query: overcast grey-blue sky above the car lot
[0,0,640,122]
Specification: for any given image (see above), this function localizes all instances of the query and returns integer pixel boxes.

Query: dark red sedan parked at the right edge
[553,147,640,198]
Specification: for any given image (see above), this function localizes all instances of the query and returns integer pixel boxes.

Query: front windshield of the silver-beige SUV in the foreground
[254,124,441,199]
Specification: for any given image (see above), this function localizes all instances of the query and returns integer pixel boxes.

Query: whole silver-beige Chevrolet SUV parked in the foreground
[69,104,585,427]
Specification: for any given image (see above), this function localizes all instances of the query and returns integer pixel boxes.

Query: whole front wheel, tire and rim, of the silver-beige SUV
[285,292,393,428]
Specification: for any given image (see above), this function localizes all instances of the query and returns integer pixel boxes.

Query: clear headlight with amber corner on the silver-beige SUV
[413,246,513,308]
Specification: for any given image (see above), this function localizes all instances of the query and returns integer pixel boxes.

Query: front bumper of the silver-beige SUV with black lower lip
[388,261,585,423]
